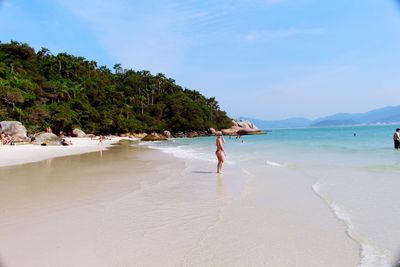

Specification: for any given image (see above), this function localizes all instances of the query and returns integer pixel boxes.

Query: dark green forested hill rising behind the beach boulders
[0,41,231,134]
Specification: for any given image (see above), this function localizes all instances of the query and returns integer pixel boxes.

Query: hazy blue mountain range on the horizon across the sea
[240,106,400,130]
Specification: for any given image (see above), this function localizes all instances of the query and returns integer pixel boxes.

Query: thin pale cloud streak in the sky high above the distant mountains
[244,28,326,43]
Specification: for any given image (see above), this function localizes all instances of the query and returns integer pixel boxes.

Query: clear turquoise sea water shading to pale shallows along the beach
[150,126,400,267]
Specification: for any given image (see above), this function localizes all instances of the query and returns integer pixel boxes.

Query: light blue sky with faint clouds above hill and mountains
[0,0,400,120]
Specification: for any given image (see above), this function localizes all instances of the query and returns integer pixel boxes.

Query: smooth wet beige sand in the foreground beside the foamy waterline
[0,146,359,267]
